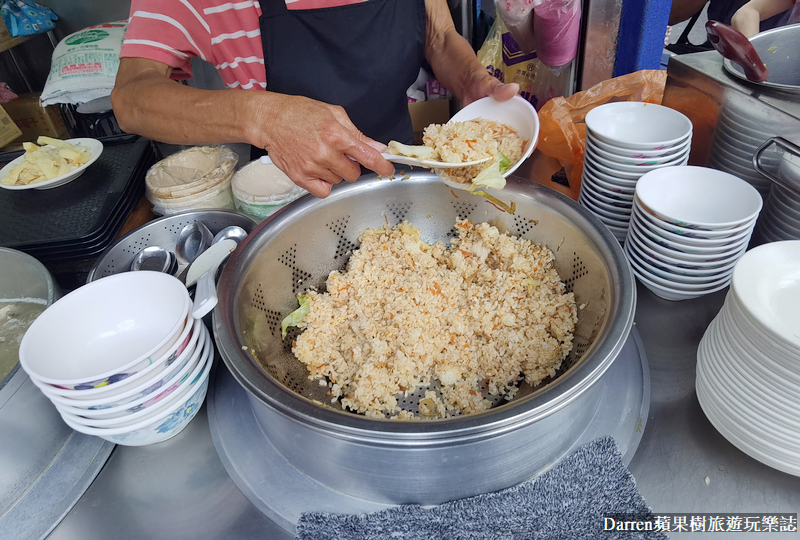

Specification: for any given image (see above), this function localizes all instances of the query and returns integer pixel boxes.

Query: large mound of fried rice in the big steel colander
[292,221,577,419]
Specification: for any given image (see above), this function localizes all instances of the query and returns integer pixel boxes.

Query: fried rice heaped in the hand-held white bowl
[422,118,528,184]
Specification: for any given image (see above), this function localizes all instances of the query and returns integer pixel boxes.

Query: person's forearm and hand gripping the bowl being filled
[425,0,519,105]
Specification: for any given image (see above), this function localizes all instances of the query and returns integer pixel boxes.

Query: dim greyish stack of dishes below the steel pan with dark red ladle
[708,104,778,198]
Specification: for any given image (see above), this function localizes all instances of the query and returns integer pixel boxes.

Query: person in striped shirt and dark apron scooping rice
[111,0,519,197]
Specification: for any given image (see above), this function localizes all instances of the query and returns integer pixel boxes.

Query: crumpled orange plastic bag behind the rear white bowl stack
[536,70,667,200]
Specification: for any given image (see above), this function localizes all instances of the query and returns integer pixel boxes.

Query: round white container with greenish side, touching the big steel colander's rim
[231,156,308,220]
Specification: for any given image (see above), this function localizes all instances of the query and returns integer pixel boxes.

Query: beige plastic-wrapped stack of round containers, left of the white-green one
[145,146,239,215]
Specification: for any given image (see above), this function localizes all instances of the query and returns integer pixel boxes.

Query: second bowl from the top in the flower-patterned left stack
[33,320,205,408]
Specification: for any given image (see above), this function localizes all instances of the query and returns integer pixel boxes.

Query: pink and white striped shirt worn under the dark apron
[120,0,366,90]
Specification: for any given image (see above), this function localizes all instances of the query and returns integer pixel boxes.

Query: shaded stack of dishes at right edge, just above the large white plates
[757,149,800,242]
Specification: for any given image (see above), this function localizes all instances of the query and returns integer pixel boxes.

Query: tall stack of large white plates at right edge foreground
[696,240,800,476]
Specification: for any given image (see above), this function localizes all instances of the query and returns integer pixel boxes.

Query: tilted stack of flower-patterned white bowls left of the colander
[19,271,214,446]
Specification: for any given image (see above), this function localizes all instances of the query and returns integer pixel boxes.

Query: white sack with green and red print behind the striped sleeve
[42,21,128,106]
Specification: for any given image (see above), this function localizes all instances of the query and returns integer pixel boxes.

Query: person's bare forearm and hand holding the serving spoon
[111,58,394,197]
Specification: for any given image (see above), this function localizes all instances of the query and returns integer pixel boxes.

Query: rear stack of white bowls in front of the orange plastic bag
[578,102,692,242]
